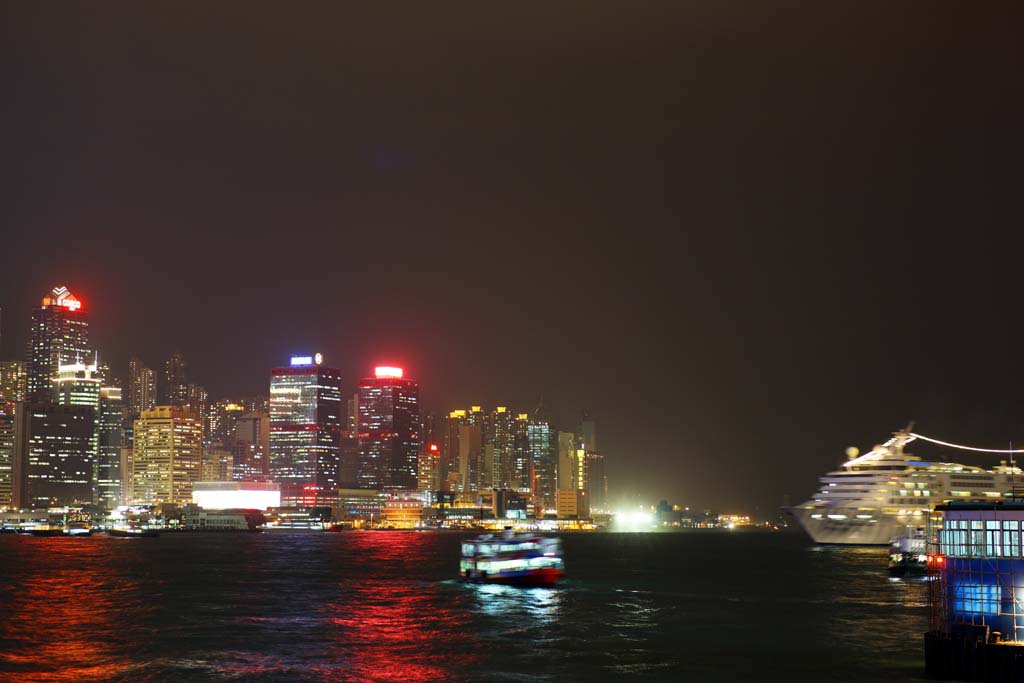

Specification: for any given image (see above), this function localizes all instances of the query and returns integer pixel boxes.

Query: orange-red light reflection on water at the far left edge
[0,539,140,683]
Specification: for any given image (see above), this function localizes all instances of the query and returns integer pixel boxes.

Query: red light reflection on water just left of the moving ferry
[327,531,479,683]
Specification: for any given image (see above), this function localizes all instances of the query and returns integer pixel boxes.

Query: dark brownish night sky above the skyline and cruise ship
[0,0,1024,511]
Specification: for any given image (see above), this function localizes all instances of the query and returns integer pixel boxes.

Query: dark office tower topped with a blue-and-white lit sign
[270,353,342,506]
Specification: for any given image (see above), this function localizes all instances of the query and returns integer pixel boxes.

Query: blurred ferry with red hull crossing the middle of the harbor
[459,530,565,586]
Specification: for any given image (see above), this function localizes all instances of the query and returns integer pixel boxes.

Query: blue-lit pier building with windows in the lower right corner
[925,501,1024,682]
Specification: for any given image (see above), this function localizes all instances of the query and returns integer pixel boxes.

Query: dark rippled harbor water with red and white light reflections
[0,531,928,683]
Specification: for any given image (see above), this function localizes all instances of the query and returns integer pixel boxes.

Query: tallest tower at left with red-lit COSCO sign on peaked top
[26,287,91,403]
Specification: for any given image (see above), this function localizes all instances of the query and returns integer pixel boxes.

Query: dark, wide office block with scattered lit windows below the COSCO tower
[12,402,95,508]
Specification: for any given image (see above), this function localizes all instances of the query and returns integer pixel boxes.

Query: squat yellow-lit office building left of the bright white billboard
[132,405,203,505]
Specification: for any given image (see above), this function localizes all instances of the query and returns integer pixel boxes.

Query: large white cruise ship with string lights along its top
[788,428,1024,546]
